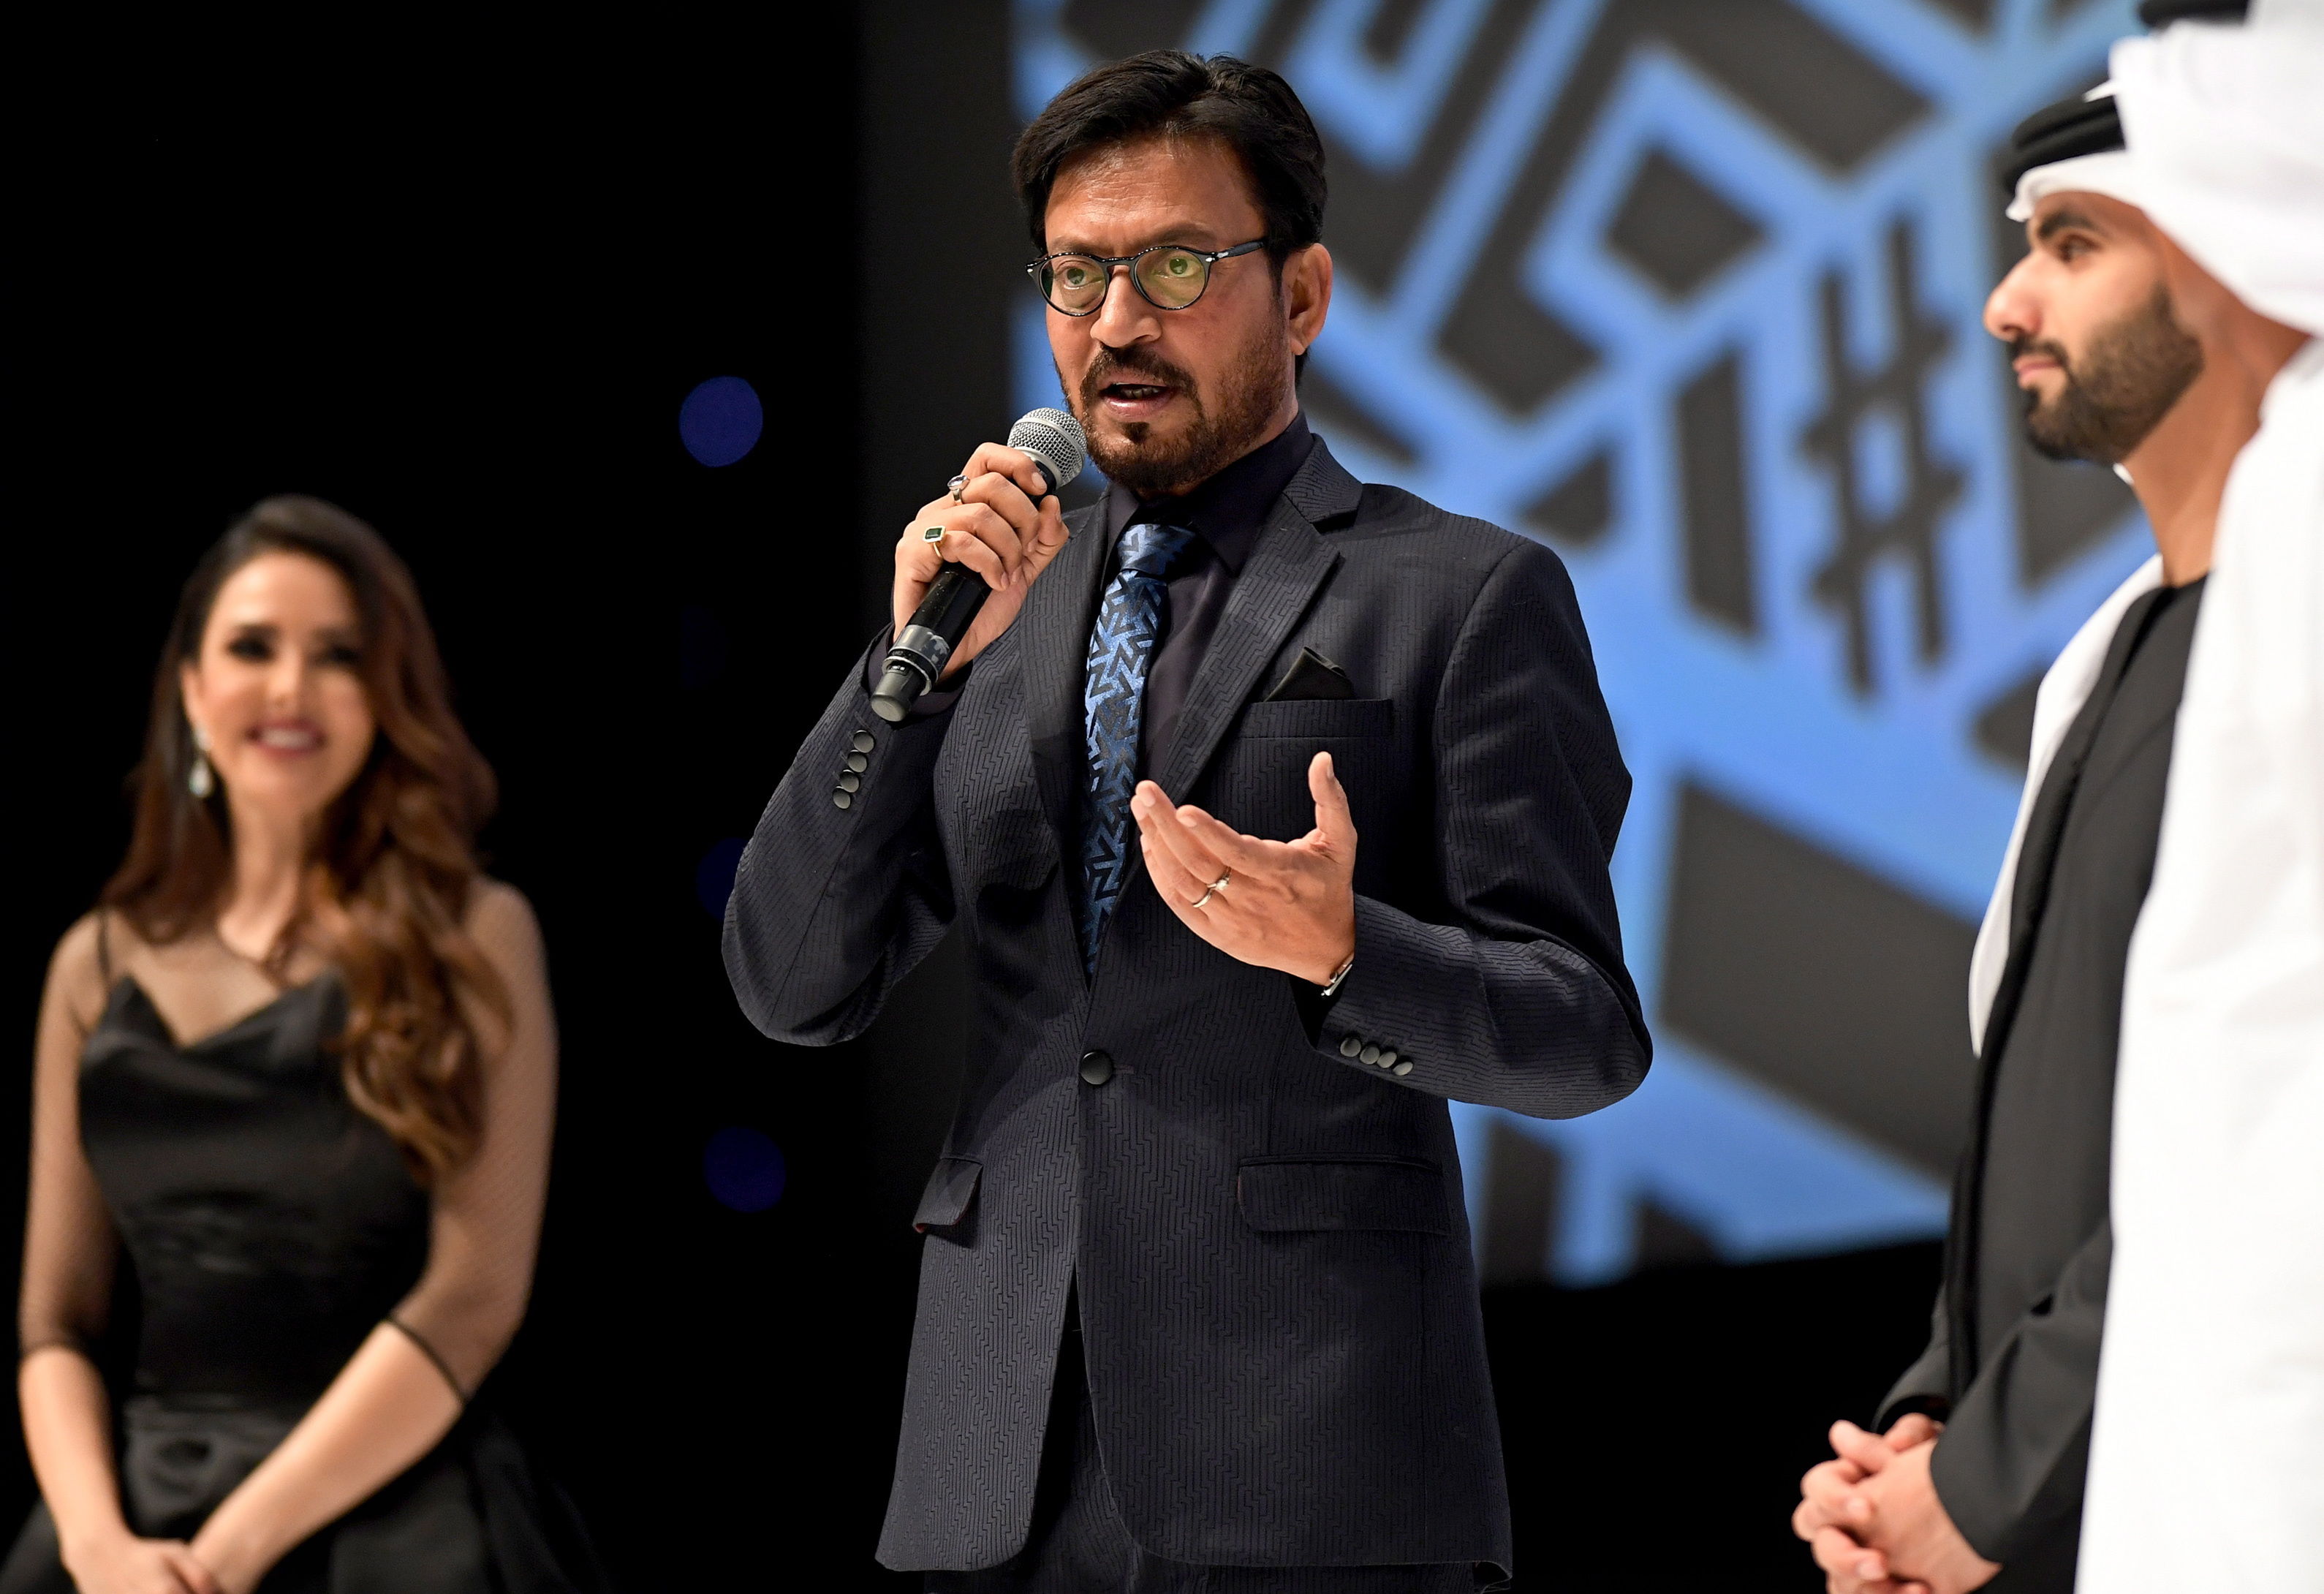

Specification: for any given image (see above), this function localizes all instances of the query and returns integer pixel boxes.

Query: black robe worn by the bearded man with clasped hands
[1890,581,2203,1590]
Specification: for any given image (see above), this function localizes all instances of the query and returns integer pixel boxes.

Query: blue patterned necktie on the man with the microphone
[1080,525,1195,974]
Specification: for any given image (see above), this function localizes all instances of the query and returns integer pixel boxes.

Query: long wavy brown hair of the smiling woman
[100,497,509,1183]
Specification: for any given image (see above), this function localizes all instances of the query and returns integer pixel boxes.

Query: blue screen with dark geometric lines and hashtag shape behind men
[1013,0,2145,1283]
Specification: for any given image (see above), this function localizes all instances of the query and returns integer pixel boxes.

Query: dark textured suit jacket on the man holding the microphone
[725,444,1648,1568]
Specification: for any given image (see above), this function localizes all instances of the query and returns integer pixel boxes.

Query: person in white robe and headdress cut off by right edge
[2080,0,2324,1594]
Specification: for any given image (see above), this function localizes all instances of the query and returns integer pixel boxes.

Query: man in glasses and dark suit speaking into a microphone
[725,51,1648,1594]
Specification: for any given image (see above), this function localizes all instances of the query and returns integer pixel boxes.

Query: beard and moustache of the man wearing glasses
[1074,328,1290,497]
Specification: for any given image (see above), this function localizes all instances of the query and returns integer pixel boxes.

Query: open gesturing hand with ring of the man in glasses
[1129,753,1355,985]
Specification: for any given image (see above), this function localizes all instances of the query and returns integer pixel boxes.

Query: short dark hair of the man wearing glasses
[1011,49,1325,272]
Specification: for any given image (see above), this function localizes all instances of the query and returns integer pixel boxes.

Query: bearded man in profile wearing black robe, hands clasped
[1794,6,2301,1594]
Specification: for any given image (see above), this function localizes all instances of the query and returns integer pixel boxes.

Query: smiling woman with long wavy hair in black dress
[0,497,602,1594]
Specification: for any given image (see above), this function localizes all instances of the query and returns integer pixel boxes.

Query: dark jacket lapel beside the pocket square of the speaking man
[1155,439,1362,801]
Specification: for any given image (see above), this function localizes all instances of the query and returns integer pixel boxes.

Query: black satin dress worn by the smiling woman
[0,976,607,1594]
